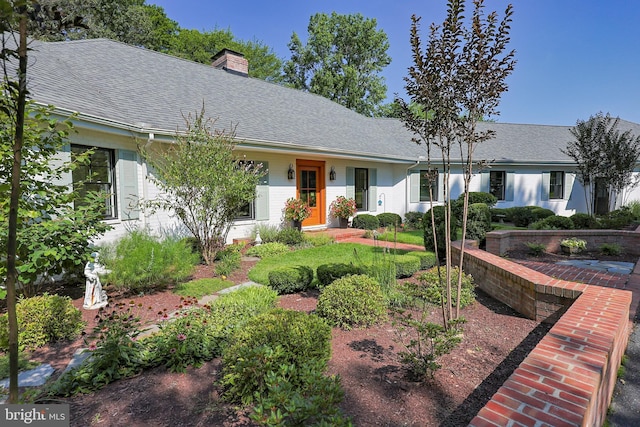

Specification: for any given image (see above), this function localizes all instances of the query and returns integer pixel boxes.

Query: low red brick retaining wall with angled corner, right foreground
[454,244,640,427]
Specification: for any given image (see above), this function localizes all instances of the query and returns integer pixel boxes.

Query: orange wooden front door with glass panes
[296,160,326,226]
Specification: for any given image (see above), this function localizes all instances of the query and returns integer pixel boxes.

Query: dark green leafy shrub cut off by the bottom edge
[249,362,352,427]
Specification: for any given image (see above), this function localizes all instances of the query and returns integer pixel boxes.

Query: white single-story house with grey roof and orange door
[22,39,640,246]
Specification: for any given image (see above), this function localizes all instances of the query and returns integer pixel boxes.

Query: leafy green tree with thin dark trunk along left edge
[0,0,106,403]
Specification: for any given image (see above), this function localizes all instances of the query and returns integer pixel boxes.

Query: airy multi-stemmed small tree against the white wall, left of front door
[141,108,265,264]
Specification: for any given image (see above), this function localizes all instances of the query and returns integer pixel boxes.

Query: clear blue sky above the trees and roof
[147,0,640,126]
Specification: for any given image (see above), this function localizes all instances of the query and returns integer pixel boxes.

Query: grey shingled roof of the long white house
[29,39,640,163]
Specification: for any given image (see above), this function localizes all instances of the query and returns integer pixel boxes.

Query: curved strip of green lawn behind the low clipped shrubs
[249,243,428,285]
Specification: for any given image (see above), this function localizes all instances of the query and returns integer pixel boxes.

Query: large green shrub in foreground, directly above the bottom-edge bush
[221,309,331,404]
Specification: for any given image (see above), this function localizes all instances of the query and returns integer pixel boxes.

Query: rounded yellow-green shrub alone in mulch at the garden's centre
[316,275,387,329]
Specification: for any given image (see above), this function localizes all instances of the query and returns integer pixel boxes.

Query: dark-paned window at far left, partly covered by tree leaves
[71,145,116,218]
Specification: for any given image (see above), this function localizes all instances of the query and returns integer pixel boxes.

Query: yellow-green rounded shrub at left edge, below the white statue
[0,293,85,351]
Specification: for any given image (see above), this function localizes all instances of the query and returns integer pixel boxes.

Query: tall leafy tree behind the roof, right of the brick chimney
[283,12,391,116]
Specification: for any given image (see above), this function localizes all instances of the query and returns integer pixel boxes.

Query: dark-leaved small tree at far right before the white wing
[562,112,640,214]
